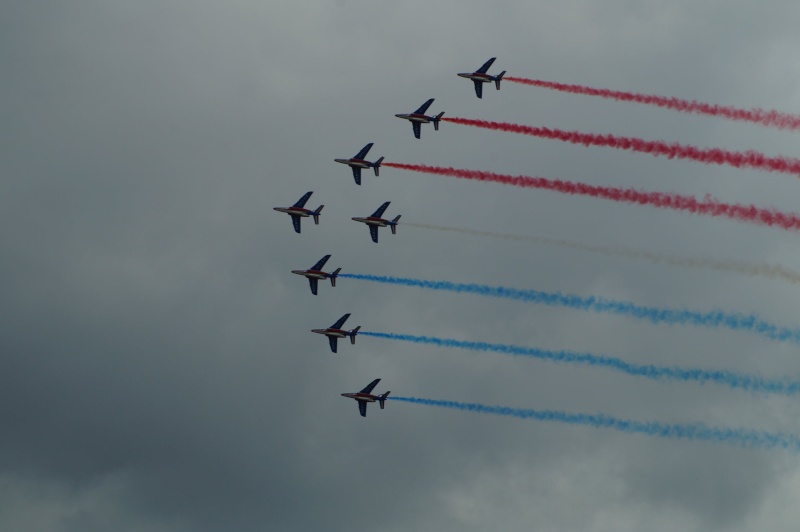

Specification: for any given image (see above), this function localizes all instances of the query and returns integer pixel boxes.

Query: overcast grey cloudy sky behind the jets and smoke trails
[0,0,800,532]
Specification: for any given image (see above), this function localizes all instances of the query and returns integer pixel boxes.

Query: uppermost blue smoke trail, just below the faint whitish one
[339,273,800,343]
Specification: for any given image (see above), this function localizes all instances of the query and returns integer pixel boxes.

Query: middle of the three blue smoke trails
[359,331,800,395]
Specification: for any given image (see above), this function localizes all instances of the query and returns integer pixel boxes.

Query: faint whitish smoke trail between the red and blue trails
[404,222,800,284]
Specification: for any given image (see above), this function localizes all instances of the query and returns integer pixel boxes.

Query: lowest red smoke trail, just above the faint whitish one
[383,162,800,230]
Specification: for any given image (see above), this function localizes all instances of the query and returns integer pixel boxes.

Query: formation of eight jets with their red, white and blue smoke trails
[274,57,800,452]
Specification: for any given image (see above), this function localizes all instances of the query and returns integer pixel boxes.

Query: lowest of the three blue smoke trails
[387,396,800,452]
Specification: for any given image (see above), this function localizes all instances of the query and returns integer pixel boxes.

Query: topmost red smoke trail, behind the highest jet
[510,76,800,129]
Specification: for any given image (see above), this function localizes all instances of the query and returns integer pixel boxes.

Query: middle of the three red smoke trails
[442,117,800,179]
